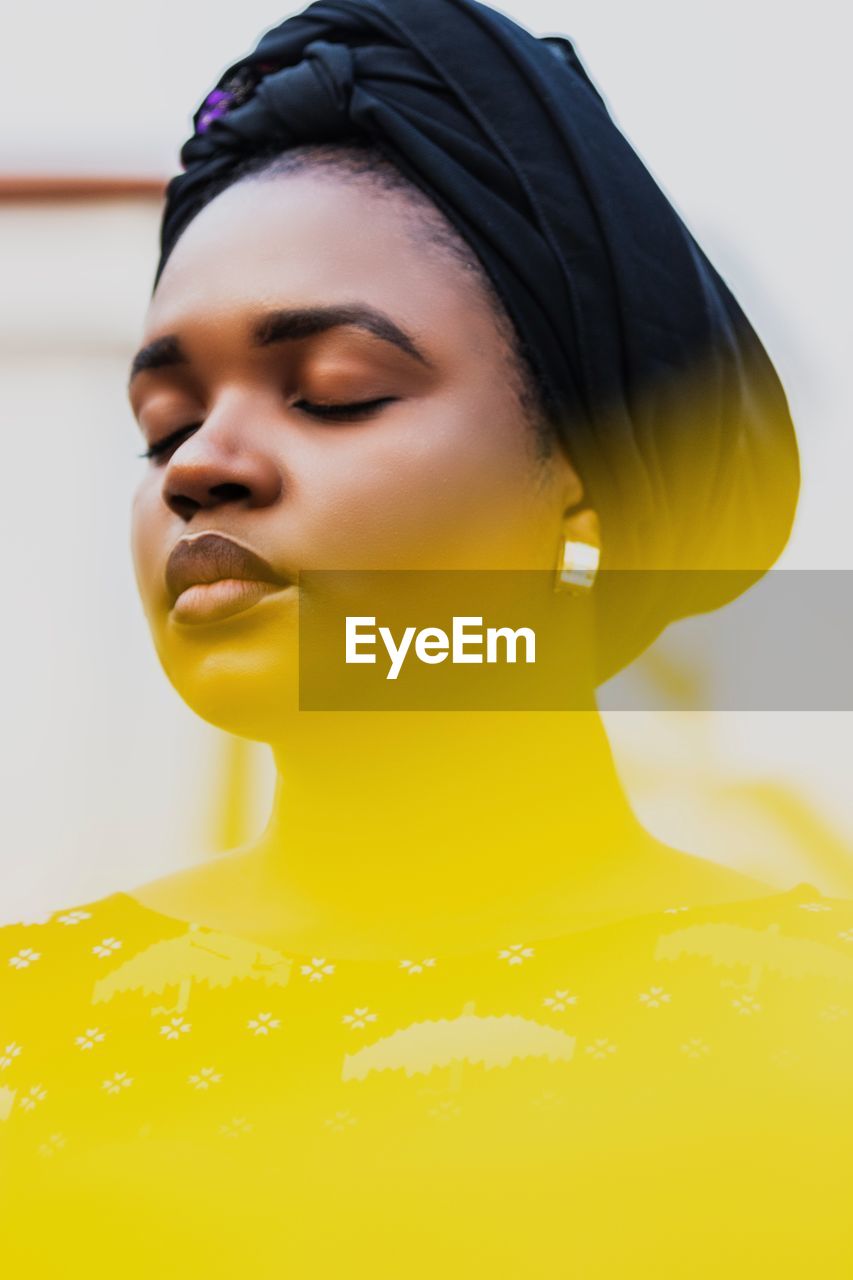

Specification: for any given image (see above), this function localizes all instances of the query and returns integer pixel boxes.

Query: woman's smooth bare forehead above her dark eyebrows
[146,173,493,334]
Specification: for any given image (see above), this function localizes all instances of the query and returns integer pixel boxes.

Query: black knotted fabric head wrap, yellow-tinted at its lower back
[158,0,799,673]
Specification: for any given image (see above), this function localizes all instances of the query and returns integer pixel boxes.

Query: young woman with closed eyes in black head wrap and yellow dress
[0,0,853,1277]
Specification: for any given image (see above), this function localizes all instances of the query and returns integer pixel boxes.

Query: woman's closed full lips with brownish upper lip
[165,532,292,622]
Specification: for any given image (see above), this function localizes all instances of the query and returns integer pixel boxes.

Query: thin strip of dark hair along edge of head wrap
[161,137,556,458]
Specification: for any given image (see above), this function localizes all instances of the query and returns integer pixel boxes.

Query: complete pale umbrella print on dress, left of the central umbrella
[92,924,292,1014]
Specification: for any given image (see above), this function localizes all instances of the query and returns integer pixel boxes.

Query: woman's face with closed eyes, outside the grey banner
[131,172,581,740]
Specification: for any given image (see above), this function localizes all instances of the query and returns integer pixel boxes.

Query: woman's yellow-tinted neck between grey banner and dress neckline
[242,712,648,942]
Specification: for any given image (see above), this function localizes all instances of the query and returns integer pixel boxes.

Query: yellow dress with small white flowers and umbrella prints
[0,884,853,1280]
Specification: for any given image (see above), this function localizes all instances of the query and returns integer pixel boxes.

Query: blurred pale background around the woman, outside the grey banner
[0,0,853,923]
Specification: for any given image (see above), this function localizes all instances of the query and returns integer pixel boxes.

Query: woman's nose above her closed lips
[163,404,283,521]
